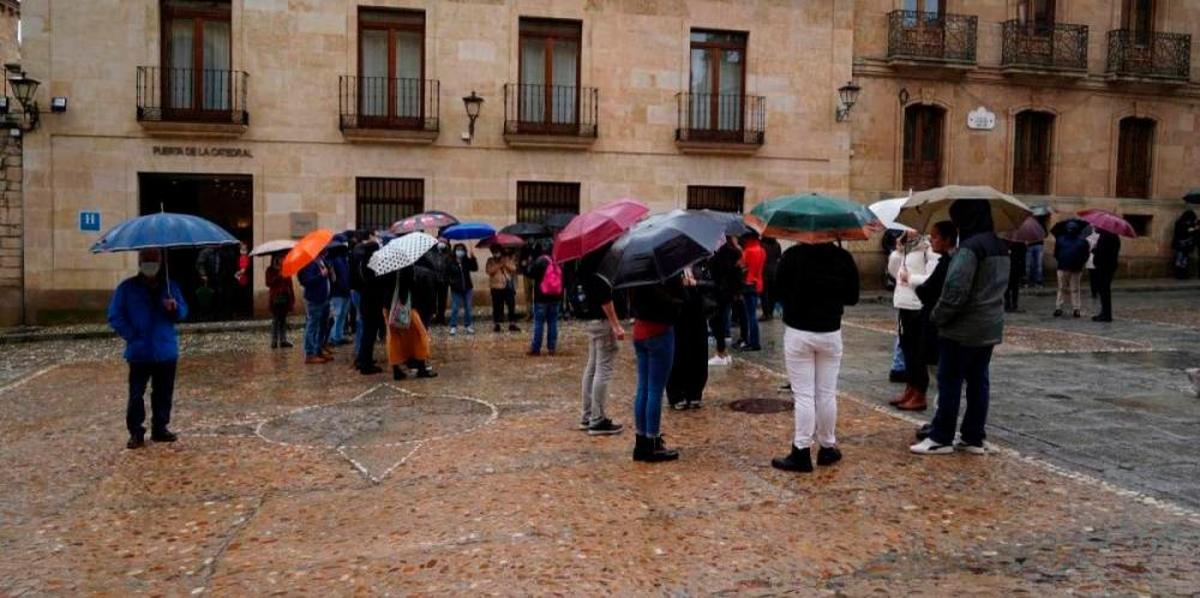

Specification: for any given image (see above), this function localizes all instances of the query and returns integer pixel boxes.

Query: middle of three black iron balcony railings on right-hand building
[1001,19,1087,72]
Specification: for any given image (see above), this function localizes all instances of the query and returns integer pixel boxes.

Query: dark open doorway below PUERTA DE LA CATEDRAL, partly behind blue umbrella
[138,173,254,321]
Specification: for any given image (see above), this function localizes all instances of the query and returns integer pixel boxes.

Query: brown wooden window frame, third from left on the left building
[517,17,583,133]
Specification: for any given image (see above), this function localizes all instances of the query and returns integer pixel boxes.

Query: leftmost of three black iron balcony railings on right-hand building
[888,11,979,65]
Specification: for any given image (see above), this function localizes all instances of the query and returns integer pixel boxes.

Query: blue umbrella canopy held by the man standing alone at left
[91,211,238,253]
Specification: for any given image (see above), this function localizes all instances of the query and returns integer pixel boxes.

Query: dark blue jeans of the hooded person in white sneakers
[929,339,995,445]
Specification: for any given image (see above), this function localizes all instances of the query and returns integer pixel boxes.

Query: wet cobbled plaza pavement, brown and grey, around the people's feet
[0,291,1200,596]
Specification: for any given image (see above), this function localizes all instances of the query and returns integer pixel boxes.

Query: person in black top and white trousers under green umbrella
[770,238,858,472]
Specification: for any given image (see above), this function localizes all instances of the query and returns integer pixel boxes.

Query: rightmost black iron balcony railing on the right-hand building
[1109,29,1192,82]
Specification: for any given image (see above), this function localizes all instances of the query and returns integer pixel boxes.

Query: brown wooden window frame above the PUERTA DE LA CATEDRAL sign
[158,0,234,121]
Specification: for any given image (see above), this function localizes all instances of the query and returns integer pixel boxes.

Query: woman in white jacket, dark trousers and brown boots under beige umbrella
[888,232,940,411]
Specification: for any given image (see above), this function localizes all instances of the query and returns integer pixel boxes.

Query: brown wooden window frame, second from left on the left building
[355,6,428,128]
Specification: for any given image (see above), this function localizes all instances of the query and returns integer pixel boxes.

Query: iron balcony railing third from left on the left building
[504,83,600,138]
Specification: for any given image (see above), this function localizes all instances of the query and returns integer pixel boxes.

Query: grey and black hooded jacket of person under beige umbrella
[931,199,1009,347]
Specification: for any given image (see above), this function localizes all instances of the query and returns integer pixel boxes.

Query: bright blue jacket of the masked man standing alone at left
[108,275,187,363]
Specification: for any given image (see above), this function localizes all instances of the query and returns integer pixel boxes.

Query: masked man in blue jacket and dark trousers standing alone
[108,249,187,449]
